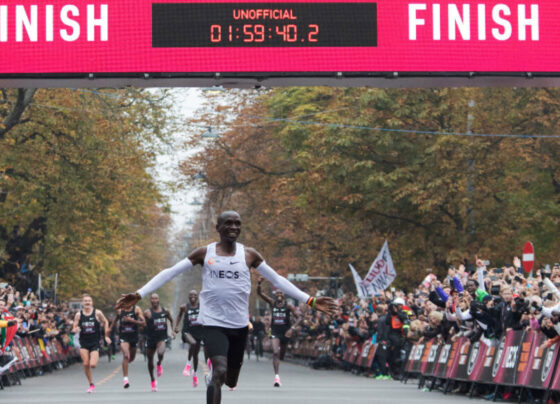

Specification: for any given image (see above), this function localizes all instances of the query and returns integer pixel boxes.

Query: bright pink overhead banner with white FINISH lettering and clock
[0,0,560,75]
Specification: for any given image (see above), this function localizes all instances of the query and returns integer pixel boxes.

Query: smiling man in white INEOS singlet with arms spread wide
[116,211,337,404]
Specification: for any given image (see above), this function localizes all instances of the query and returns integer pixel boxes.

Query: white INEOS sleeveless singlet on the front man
[198,242,251,328]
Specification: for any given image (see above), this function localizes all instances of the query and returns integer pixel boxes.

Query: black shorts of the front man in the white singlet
[203,327,249,369]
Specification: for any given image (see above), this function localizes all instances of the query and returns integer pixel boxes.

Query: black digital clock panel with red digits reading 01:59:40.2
[152,3,377,48]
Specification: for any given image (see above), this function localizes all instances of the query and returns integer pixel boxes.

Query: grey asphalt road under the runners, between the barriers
[0,347,480,404]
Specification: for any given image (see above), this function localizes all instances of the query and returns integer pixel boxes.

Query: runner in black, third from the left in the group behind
[144,293,175,392]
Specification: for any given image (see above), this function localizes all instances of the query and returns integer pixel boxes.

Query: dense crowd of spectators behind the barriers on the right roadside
[260,257,560,398]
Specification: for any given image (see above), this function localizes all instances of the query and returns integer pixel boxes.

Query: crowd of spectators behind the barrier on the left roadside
[0,283,79,368]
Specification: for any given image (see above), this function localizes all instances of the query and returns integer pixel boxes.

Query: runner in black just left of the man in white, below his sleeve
[175,290,203,387]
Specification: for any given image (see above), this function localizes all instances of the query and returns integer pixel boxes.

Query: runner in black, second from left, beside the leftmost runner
[111,305,146,389]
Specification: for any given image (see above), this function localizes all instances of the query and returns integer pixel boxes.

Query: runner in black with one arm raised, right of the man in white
[257,277,301,387]
